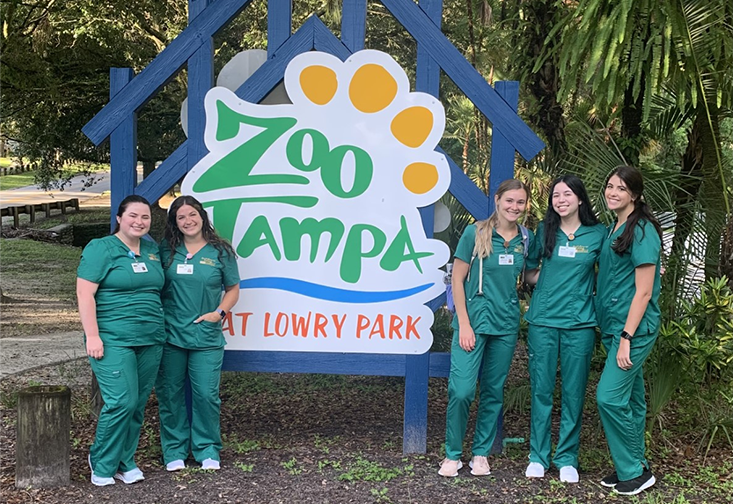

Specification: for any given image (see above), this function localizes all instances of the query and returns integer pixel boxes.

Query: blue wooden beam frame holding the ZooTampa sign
[82,0,544,453]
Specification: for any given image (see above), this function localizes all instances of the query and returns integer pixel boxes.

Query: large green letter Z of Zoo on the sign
[193,101,308,192]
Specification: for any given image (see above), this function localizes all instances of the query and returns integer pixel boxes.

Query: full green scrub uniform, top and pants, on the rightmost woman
[596,221,661,481]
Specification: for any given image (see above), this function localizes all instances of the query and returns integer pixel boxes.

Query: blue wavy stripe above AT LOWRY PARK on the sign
[239,277,433,303]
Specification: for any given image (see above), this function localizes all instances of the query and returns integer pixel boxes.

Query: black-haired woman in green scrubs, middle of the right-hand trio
[524,175,606,483]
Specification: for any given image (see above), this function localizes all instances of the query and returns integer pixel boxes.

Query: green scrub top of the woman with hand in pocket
[160,242,239,349]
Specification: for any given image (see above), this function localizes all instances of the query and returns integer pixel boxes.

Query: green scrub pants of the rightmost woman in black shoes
[596,333,657,481]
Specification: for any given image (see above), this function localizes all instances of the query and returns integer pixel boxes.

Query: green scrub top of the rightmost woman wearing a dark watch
[596,221,662,335]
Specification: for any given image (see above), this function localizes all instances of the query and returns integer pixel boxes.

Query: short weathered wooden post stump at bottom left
[15,385,71,488]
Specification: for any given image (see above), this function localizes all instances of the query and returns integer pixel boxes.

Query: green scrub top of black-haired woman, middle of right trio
[524,222,607,329]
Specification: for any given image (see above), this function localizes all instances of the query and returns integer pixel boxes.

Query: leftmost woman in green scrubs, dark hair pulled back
[76,195,165,486]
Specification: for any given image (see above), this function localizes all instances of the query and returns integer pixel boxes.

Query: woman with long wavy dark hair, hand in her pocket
[155,196,239,471]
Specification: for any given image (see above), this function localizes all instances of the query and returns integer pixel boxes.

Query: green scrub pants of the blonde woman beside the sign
[445,330,517,460]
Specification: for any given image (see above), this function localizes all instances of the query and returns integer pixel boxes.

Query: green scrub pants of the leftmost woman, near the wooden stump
[89,345,163,478]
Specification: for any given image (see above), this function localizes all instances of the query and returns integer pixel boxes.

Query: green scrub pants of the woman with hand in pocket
[155,344,224,464]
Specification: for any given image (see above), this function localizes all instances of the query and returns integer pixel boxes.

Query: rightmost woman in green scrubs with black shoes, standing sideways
[596,166,662,495]
